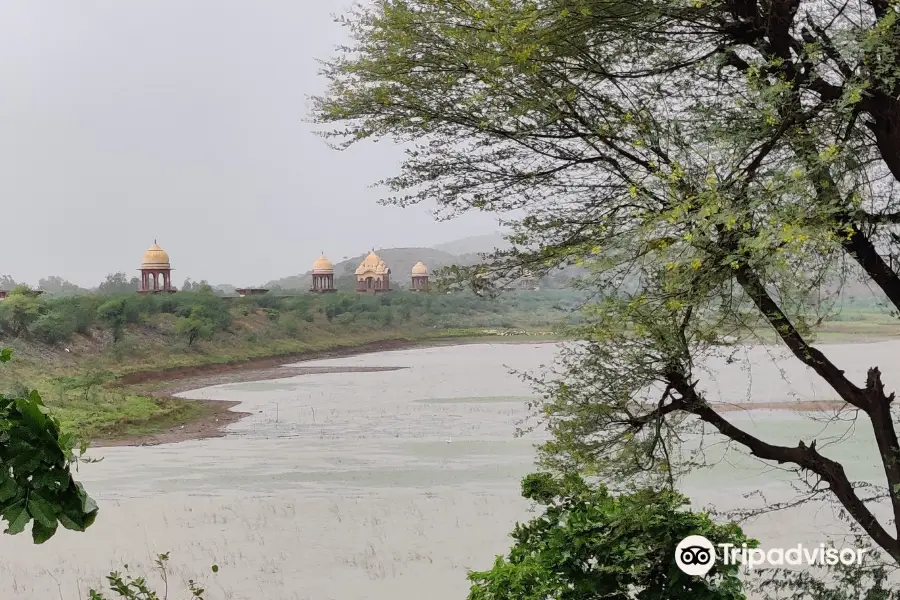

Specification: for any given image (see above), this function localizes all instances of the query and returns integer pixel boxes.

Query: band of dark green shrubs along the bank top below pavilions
[0,290,581,344]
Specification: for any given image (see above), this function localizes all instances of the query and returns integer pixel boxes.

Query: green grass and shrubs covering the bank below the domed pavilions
[0,286,581,439]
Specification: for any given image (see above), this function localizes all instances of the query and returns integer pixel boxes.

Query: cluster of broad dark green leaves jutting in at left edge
[0,350,97,544]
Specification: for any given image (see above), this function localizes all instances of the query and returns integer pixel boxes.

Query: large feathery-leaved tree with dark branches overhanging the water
[314,0,900,560]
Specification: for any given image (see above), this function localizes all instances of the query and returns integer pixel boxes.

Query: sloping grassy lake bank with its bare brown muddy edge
[0,292,900,445]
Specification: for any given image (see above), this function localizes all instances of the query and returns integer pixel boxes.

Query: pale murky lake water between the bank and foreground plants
[0,342,900,600]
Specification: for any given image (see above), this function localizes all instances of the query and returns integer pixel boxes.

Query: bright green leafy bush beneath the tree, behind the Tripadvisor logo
[469,473,755,600]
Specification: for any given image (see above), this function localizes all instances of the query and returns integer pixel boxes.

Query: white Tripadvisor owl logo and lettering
[675,535,868,577]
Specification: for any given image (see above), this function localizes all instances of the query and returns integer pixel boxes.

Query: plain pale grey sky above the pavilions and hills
[0,0,496,286]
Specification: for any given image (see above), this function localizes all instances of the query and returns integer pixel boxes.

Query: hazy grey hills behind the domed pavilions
[266,248,471,290]
